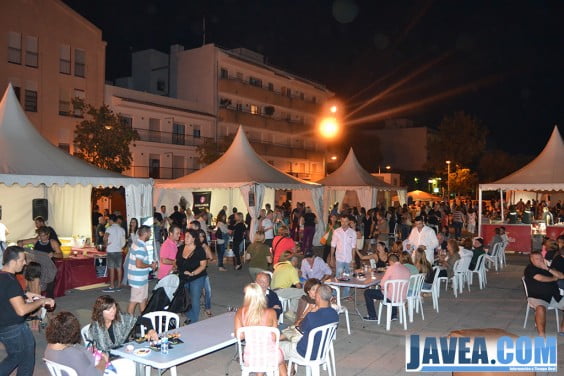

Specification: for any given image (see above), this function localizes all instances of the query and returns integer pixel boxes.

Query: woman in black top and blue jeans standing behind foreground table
[176,228,207,324]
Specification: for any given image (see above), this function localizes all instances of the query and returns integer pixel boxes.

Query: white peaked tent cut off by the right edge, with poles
[478,126,564,234]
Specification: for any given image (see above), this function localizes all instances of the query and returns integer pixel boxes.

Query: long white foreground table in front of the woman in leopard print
[110,312,237,376]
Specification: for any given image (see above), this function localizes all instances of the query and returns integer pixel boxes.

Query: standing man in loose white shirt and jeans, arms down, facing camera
[331,215,356,298]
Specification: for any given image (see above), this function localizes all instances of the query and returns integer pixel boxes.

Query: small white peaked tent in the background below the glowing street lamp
[318,148,407,213]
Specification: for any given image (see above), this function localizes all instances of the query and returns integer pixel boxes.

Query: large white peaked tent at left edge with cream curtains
[0,85,153,241]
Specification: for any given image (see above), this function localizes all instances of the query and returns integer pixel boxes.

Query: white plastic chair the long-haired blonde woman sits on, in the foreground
[237,326,280,376]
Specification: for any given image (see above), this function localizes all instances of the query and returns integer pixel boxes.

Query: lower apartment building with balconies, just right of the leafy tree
[105,85,215,179]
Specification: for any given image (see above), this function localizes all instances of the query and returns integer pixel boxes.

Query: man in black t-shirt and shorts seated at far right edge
[524,251,564,337]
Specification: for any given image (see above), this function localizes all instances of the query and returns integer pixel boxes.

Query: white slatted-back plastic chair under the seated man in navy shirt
[288,322,338,376]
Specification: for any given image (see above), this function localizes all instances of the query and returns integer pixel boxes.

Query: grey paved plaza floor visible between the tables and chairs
[0,255,564,376]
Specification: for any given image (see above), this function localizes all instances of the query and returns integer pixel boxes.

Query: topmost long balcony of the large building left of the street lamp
[218,77,320,114]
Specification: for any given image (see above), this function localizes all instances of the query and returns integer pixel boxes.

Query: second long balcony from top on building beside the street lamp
[218,106,312,134]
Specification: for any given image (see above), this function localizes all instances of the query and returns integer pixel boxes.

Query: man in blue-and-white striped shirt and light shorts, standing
[127,226,157,315]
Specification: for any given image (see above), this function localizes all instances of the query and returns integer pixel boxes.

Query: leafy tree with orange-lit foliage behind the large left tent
[73,99,139,172]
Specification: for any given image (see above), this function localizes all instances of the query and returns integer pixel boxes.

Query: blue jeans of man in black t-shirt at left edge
[0,323,35,376]
